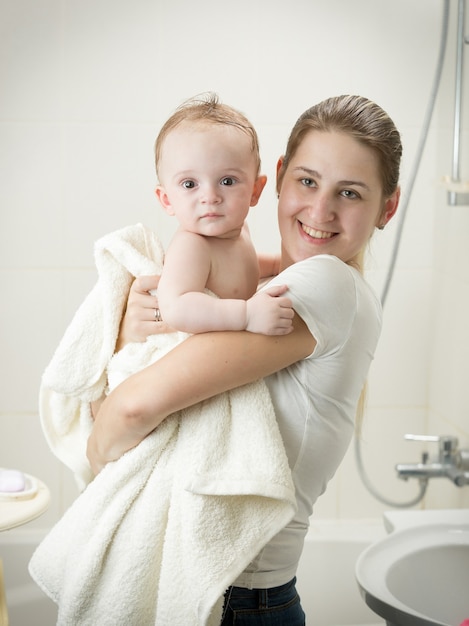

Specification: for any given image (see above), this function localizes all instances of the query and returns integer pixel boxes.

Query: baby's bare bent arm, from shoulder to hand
[157,232,293,335]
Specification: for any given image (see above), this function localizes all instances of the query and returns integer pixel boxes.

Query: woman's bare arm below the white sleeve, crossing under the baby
[87,316,316,473]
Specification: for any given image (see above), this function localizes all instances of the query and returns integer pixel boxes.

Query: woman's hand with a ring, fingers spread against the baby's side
[116,276,174,352]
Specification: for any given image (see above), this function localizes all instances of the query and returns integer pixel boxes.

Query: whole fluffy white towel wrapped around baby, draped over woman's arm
[30,226,295,626]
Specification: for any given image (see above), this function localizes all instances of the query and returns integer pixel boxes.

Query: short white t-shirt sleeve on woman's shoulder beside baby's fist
[260,255,357,357]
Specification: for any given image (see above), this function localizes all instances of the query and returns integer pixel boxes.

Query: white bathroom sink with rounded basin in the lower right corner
[356,510,469,626]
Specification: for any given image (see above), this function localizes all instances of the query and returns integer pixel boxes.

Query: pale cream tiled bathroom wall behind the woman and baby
[0,0,469,527]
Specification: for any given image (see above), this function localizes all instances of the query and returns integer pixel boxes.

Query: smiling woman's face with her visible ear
[278,131,399,268]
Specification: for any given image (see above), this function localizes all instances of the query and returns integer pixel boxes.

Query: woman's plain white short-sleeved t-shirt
[233,255,381,589]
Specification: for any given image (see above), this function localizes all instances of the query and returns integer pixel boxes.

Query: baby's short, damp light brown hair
[155,92,261,174]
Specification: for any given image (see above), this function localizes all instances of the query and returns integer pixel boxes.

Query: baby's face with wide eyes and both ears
[156,123,265,237]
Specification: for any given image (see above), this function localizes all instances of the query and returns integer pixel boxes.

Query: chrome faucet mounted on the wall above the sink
[396,435,469,487]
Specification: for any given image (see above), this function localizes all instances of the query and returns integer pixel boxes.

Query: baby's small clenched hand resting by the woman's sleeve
[246,285,294,335]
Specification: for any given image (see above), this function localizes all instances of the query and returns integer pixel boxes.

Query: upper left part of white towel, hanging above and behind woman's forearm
[39,224,164,489]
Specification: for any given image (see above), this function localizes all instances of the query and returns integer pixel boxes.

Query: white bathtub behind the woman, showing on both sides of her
[0,520,386,626]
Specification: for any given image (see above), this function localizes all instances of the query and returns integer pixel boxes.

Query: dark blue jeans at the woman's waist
[220,578,306,626]
